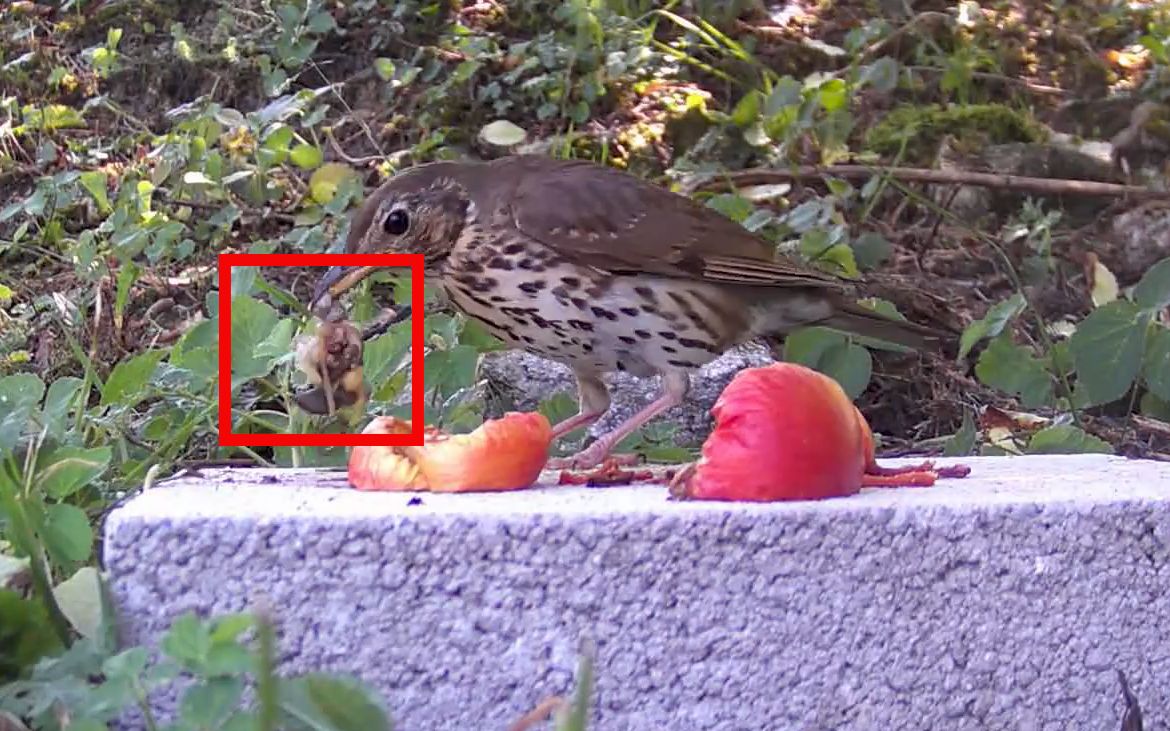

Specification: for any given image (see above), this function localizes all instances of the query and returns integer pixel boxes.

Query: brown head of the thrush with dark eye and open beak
[309,163,474,311]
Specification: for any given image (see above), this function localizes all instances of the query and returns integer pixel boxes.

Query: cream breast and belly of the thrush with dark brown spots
[441,226,727,377]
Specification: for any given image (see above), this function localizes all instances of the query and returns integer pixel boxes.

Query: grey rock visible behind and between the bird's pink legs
[480,344,775,447]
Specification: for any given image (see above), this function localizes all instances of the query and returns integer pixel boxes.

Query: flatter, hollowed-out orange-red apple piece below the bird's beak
[349,412,552,492]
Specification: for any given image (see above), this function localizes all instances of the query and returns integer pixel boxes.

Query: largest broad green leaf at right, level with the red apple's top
[1068,299,1147,406]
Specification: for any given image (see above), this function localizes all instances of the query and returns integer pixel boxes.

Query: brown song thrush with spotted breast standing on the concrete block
[314,156,938,469]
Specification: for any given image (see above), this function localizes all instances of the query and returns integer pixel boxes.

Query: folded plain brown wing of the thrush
[498,157,844,288]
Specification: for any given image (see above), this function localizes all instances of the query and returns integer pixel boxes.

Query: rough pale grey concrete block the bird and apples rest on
[104,455,1170,731]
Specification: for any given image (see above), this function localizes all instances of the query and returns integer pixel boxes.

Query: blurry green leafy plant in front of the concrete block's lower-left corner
[0,598,392,731]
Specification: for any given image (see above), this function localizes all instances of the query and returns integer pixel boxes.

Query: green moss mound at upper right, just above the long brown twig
[866,104,1046,159]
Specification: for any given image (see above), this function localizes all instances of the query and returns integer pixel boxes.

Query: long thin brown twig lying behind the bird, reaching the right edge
[682,165,1170,200]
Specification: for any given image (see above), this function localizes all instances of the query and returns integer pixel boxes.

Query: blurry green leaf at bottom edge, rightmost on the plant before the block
[280,673,392,731]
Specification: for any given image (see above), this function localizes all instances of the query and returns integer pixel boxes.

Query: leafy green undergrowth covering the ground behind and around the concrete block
[0,0,1170,730]
